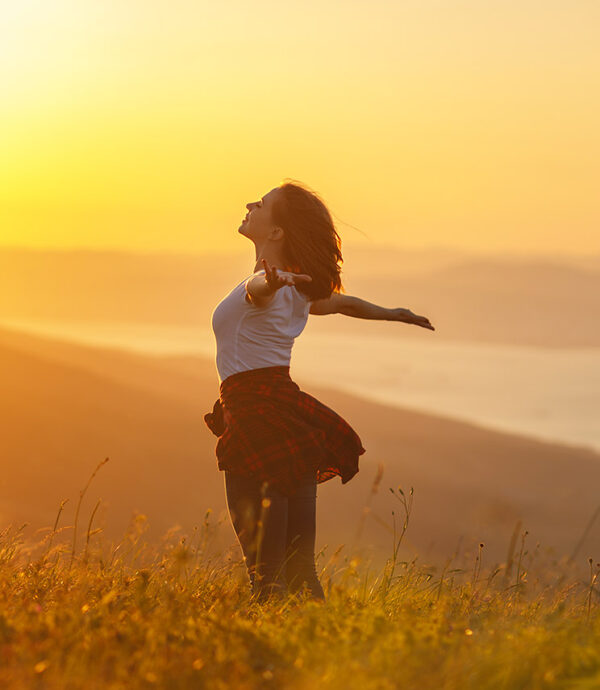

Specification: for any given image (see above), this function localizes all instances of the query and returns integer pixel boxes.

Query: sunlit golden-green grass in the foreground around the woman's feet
[0,462,600,690]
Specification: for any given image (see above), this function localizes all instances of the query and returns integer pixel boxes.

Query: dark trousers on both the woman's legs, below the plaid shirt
[224,470,325,601]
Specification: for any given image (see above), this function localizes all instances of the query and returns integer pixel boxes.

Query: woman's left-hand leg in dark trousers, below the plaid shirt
[225,470,288,601]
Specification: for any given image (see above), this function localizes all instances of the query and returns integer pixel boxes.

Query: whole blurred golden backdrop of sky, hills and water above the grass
[0,0,600,564]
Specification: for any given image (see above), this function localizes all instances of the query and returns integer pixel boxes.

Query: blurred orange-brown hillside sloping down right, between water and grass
[0,322,600,563]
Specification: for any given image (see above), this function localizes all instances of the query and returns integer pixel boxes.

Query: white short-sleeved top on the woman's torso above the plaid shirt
[211,269,310,382]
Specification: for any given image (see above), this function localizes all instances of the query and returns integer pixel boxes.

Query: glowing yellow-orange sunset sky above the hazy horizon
[0,0,600,253]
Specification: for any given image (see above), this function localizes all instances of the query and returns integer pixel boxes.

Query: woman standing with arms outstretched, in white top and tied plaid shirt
[204,183,435,601]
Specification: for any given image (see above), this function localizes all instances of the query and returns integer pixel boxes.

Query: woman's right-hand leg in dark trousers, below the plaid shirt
[286,477,325,601]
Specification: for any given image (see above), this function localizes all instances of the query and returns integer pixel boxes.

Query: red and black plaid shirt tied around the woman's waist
[204,366,365,496]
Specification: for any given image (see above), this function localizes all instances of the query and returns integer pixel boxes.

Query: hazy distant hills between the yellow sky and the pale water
[0,245,600,347]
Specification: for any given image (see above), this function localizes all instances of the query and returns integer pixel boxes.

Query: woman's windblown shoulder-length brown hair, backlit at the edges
[272,181,344,301]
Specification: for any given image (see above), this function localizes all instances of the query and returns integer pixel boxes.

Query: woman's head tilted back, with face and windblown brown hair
[240,182,343,300]
